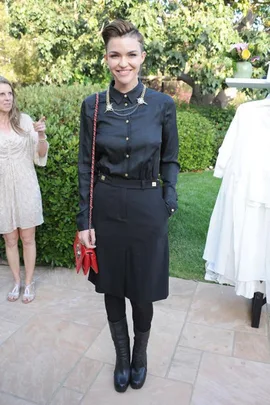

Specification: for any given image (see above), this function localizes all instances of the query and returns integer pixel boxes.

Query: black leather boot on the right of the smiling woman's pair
[130,329,150,389]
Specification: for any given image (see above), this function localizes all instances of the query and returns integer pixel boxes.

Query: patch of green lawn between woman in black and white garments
[169,172,221,280]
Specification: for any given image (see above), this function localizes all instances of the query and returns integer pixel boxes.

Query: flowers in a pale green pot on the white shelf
[229,42,259,79]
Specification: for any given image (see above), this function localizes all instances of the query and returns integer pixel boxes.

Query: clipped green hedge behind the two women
[0,85,232,267]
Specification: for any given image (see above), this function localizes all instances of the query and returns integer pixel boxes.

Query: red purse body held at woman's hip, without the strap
[73,232,98,275]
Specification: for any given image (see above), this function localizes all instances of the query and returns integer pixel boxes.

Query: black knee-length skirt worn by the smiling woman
[89,175,169,303]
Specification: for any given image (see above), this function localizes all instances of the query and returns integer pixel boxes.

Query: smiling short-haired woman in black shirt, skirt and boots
[77,20,179,392]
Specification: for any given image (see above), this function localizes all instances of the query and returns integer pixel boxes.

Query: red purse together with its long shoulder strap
[73,93,99,275]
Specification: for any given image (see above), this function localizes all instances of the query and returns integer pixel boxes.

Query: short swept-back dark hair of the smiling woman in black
[101,19,144,51]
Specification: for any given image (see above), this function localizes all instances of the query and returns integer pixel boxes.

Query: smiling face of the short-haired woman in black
[105,36,146,92]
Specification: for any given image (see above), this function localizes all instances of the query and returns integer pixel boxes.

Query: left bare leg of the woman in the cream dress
[4,229,20,284]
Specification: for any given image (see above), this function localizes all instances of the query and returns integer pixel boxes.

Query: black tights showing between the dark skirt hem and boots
[105,294,153,332]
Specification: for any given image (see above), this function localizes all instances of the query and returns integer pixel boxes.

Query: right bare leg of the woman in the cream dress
[20,227,36,285]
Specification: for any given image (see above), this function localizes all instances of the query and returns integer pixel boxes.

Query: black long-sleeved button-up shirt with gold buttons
[77,81,179,230]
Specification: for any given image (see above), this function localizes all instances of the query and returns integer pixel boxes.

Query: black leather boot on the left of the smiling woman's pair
[109,317,130,392]
